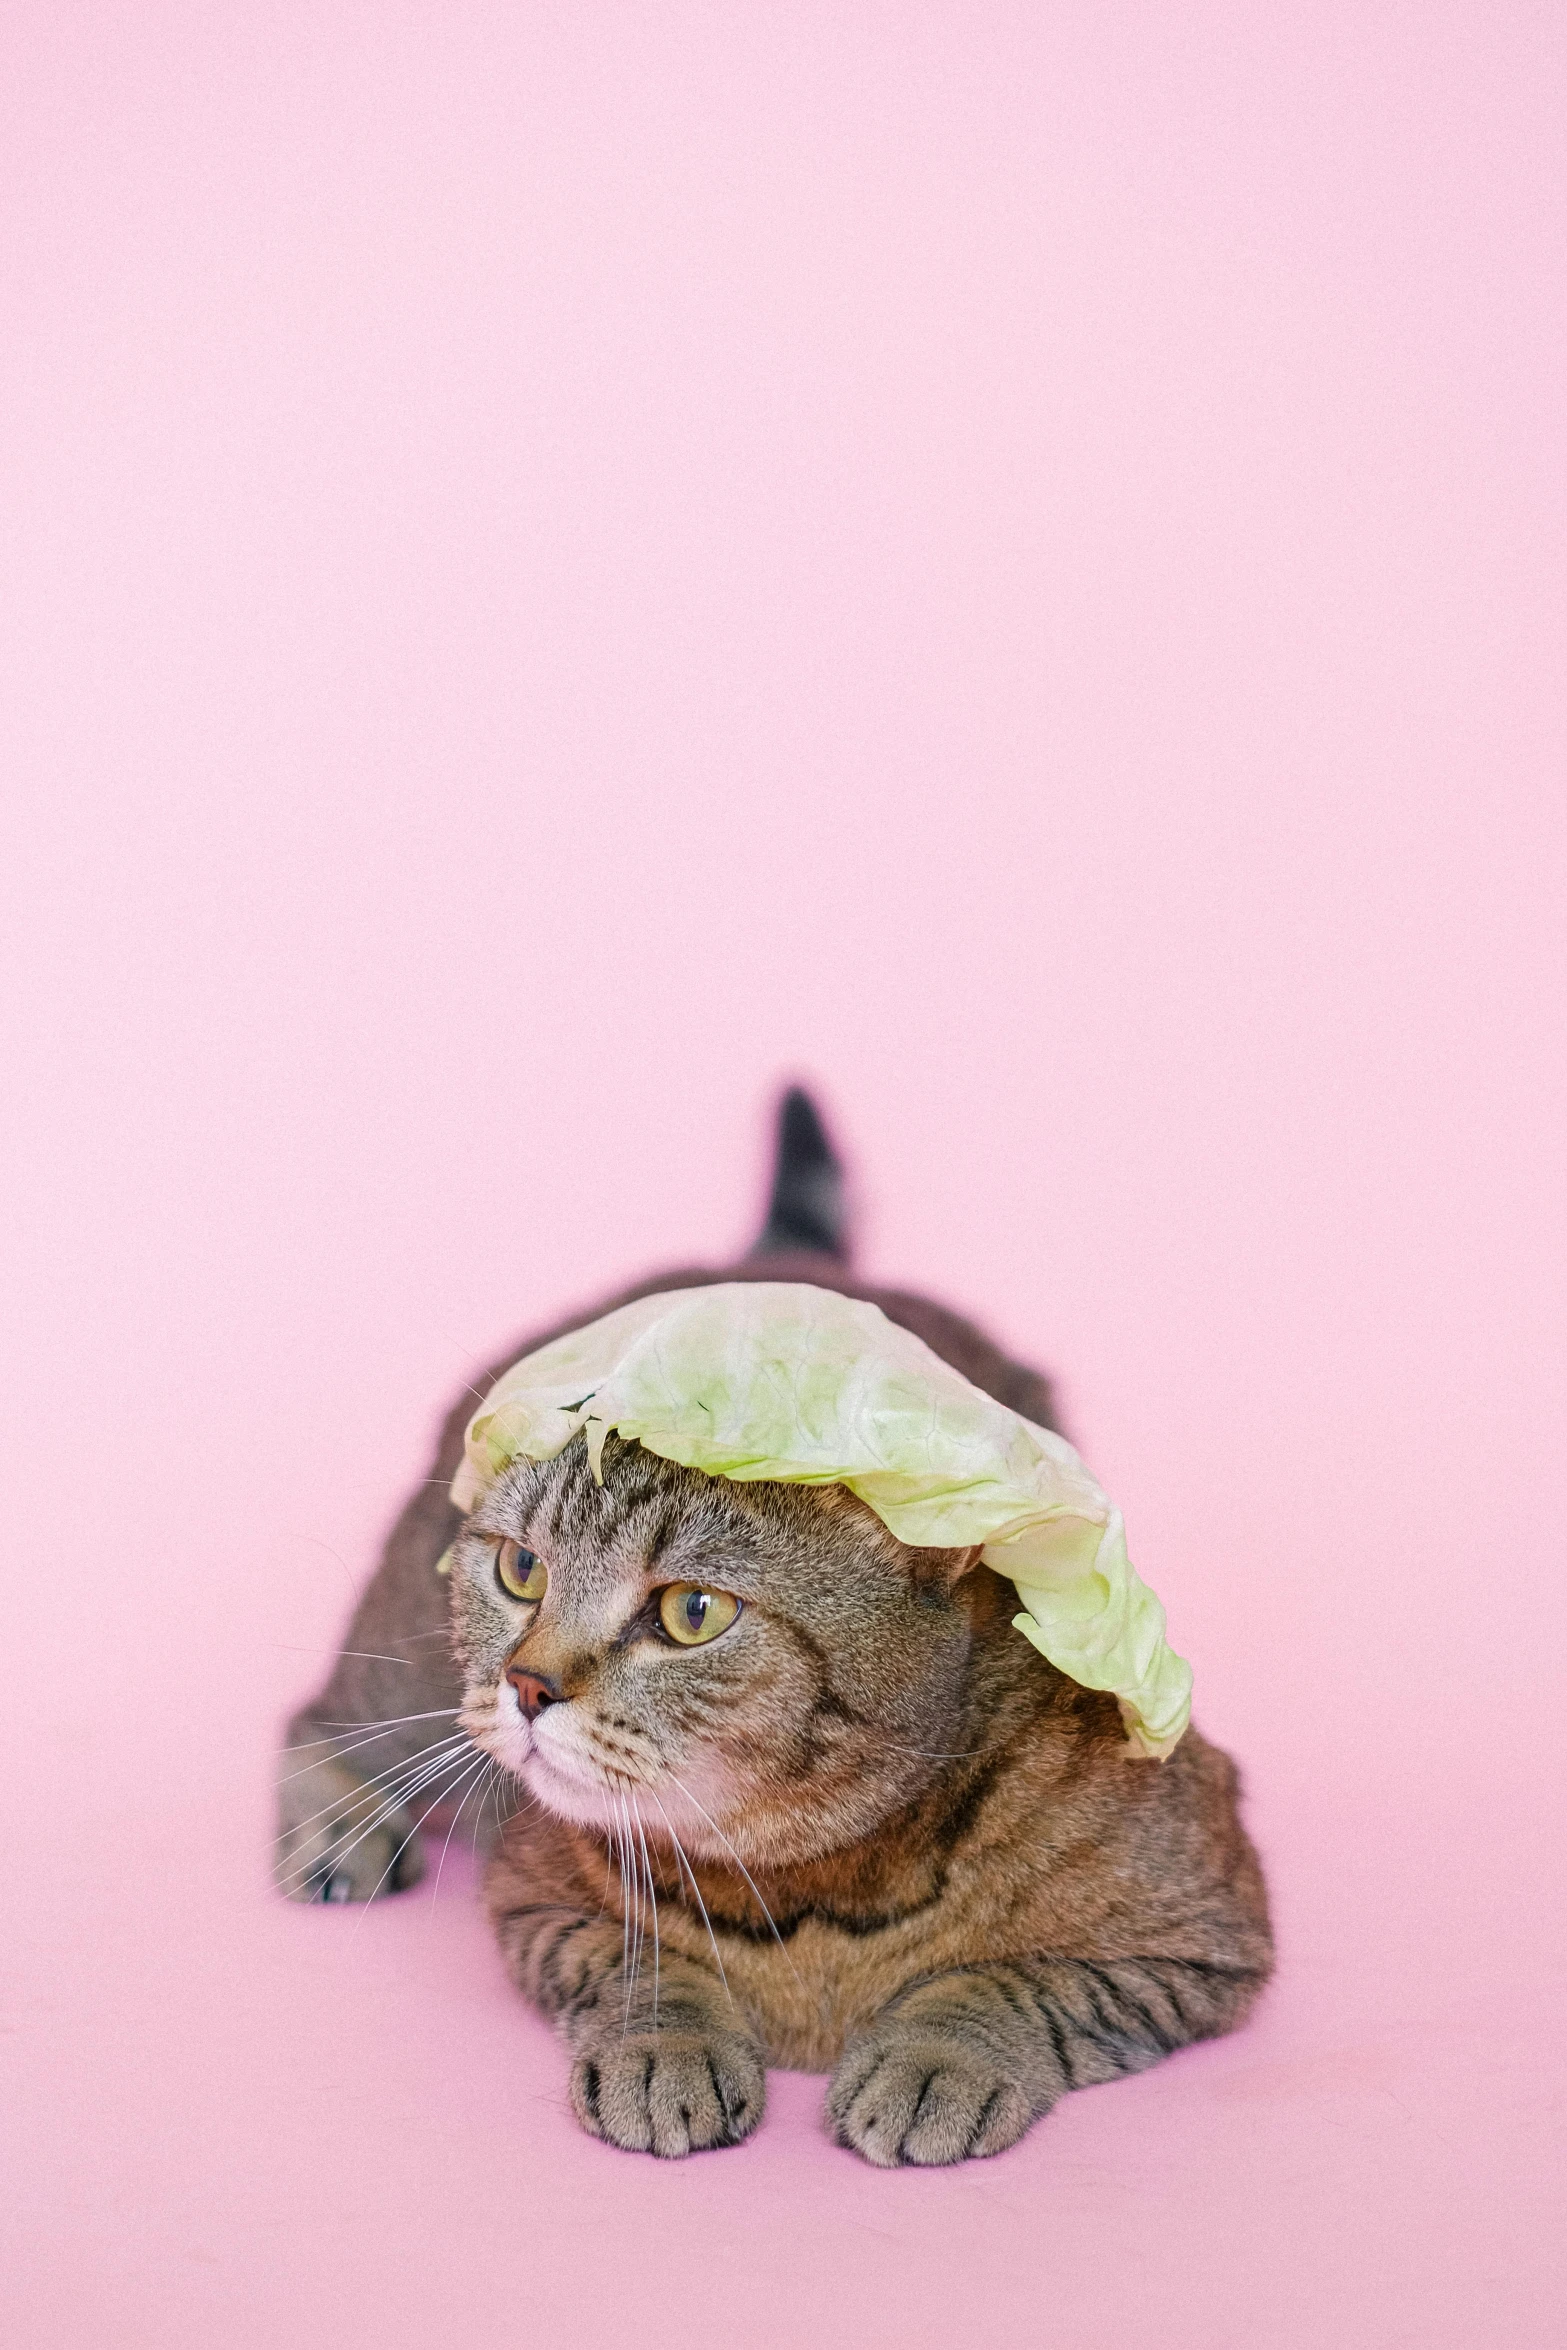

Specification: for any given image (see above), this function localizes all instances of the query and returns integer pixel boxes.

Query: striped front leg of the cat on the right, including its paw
[827,1958,1264,2167]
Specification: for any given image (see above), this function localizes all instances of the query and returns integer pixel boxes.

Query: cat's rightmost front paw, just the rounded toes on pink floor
[827,2021,1034,2169]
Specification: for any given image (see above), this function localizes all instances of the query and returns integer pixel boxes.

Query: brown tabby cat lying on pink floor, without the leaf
[277,1090,1273,2164]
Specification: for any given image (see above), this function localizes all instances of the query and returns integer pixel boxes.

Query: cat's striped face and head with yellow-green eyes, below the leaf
[451,1438,977,1866]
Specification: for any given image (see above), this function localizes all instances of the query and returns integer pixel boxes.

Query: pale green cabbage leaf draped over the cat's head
[451,1281,1191,1758]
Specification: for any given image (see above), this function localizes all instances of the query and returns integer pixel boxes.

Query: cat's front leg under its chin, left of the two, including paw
[493,1899,766,2155]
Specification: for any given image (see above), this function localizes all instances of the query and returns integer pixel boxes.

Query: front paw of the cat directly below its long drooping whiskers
[571,2030,766,2155]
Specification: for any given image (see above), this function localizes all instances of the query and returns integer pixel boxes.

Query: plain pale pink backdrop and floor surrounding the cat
[0,0,1567,2350]
